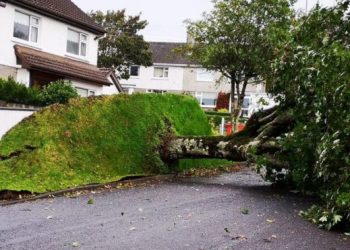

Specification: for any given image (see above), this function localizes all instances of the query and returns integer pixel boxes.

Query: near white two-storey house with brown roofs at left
[0,0,122,96]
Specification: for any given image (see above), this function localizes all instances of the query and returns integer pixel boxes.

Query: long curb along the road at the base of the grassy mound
[0,174,176,207]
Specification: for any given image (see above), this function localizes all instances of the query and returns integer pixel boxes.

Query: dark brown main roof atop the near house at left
[3,0,106,35]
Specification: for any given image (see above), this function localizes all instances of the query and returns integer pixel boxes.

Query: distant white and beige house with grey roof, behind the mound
[121,42,267,116]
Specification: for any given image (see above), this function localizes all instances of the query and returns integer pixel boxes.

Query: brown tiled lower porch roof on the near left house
[14,45,111,86]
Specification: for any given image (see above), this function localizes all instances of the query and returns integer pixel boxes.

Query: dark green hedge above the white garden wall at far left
[0,78,42,106]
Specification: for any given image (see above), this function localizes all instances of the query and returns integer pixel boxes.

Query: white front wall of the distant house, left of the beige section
[121,64,184,92]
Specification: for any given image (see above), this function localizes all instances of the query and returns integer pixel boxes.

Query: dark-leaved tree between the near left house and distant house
[90,10,152,79]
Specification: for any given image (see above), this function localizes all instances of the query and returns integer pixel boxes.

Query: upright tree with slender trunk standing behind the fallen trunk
[182,0,294,129]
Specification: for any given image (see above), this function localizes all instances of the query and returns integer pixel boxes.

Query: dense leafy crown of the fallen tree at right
[271,1,350,229]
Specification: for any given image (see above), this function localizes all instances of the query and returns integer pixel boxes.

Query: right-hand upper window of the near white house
[67,29,88,57]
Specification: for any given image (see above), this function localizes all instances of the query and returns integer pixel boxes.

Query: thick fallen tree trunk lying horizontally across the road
[160,108,293,168]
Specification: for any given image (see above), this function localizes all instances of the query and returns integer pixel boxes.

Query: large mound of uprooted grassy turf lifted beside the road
[0,94,231,193]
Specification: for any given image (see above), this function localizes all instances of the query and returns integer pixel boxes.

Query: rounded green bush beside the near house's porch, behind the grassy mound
[40,80,78,105]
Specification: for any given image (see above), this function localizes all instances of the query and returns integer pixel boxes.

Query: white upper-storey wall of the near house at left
[0,4,98,85]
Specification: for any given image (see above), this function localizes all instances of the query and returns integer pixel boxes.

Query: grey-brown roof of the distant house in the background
[149,42,192,65]
